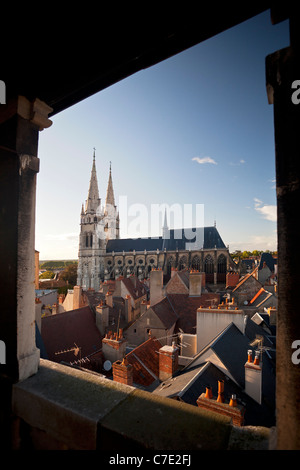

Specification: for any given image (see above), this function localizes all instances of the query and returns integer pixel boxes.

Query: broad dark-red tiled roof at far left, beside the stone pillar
[41,307,102,362]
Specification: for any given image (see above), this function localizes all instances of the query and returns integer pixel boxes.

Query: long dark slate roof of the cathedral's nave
[106,227,226,253]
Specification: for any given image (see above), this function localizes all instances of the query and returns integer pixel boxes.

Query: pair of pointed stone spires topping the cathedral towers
[82,148,115,213]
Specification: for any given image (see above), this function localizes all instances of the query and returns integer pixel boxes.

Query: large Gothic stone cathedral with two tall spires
[77,151,232,291]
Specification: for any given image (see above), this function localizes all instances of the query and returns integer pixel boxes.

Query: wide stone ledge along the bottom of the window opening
[12,360,269,451]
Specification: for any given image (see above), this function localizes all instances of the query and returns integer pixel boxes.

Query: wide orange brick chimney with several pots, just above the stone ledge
[197,380,245,426]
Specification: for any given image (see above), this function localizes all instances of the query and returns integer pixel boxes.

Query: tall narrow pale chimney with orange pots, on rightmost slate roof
[245,350,262,405]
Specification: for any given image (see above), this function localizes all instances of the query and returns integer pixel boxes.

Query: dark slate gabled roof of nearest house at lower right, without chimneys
[151,319,275,426]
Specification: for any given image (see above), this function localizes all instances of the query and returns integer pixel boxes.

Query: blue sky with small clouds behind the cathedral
[36,11,289,260]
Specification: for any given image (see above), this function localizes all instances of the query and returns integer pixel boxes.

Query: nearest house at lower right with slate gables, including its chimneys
[152,316,275,426]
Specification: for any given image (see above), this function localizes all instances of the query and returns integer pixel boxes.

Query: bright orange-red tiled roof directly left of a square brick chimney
[126,337,162,387]
